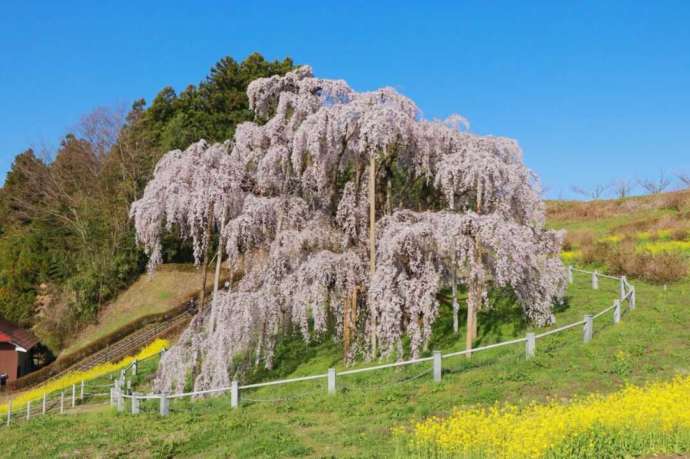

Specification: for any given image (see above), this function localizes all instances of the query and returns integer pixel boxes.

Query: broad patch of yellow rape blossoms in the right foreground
[398,376,690,458]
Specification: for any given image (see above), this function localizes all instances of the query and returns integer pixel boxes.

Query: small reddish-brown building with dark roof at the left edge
[0,317,42,382]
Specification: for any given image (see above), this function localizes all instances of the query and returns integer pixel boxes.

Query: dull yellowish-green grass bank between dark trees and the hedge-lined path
[61,264,206,355]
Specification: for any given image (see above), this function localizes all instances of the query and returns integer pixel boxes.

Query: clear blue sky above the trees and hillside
[0,0,690,197]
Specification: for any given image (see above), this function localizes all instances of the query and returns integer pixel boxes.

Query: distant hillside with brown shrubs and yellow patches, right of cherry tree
[548,190,690,284]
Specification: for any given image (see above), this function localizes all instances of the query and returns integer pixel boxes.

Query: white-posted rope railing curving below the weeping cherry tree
[7,266,635,425]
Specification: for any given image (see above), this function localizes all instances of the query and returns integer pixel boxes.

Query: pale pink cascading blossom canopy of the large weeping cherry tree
[132,67,565,391]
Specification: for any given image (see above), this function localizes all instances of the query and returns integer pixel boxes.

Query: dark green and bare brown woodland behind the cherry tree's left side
[0,53,294,350]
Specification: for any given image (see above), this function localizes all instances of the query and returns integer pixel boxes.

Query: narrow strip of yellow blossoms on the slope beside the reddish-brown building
[0,339,170,414]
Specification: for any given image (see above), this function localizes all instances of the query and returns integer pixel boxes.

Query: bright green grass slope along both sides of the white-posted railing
[1,275,690,458]
